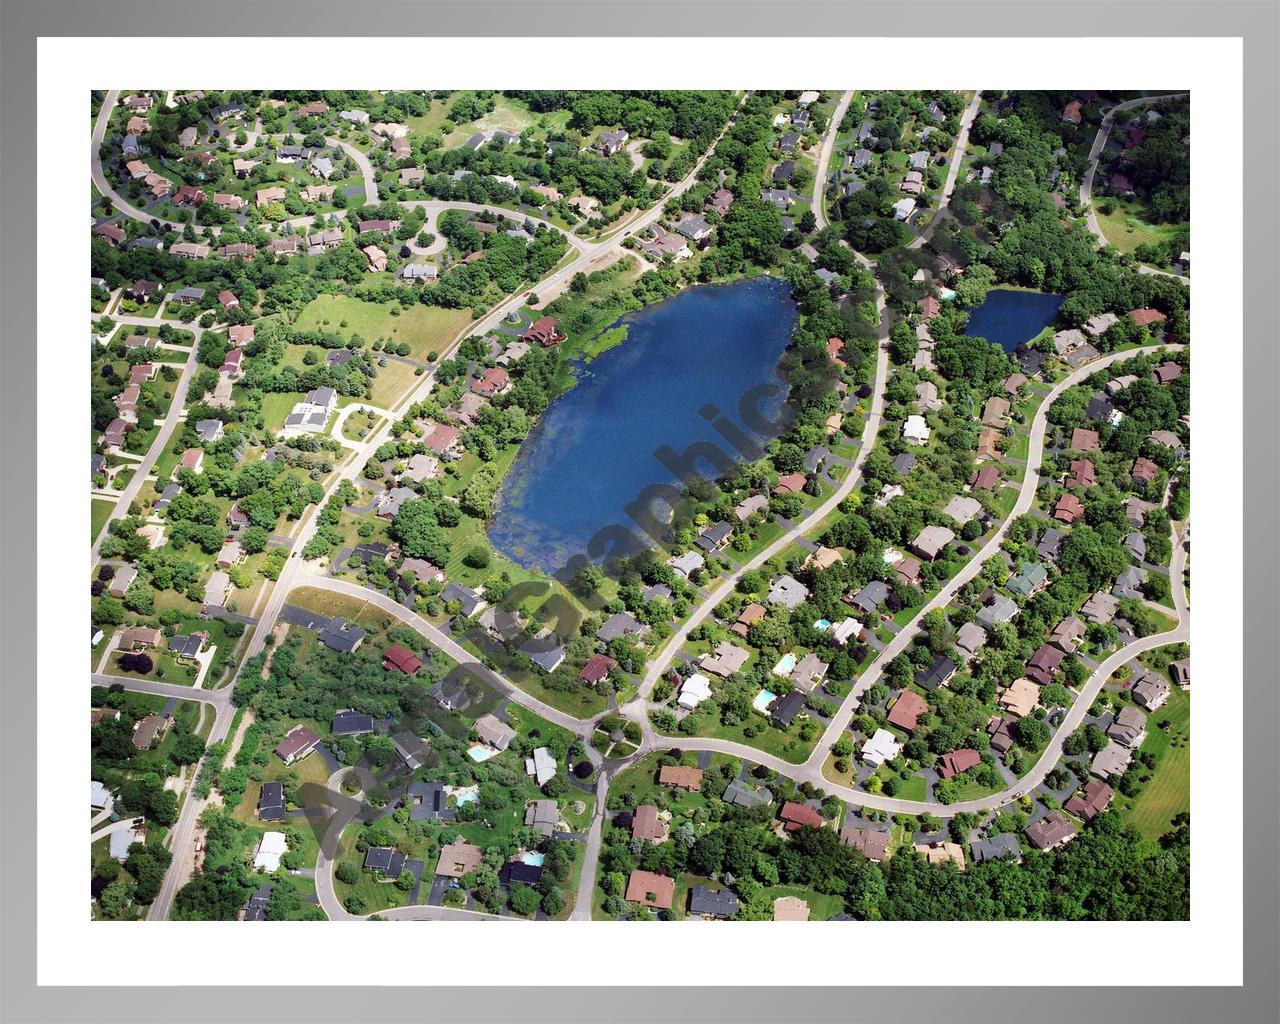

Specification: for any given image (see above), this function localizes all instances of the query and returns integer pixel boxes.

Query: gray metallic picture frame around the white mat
[0,0,1280,1024]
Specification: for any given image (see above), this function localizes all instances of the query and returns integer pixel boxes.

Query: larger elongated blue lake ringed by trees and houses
[489,278,797,573]
